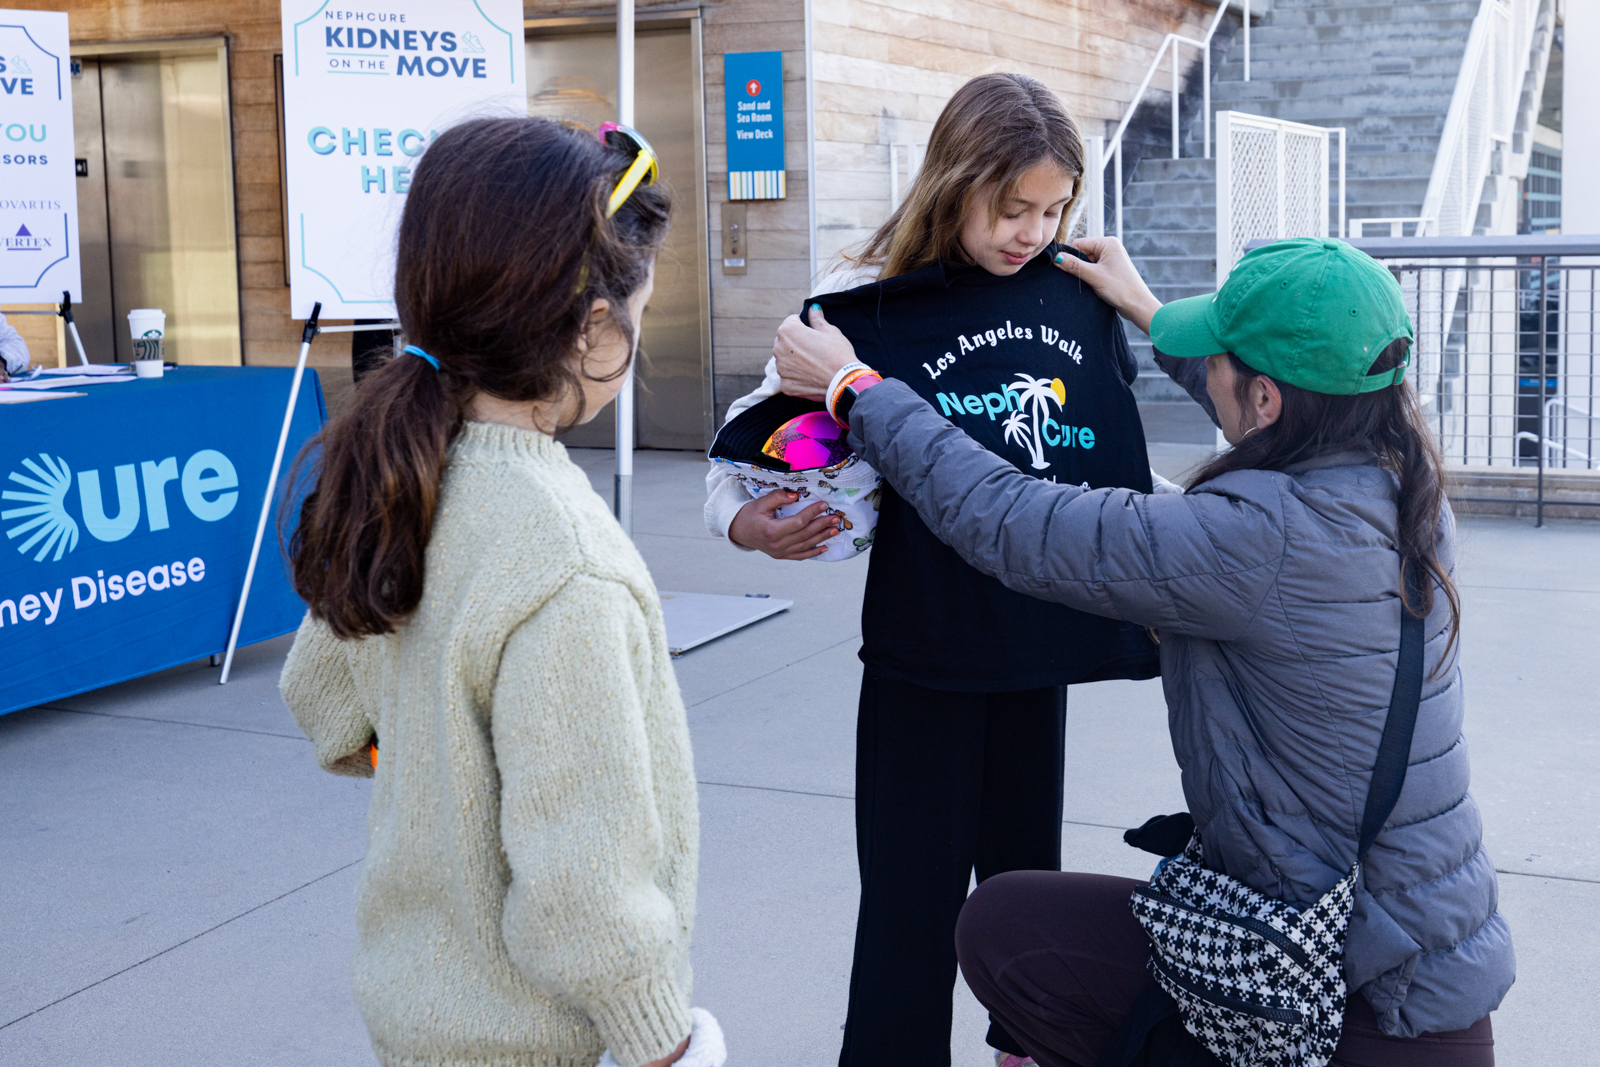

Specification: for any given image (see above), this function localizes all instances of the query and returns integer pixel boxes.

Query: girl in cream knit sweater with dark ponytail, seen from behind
[282,118,722,1067]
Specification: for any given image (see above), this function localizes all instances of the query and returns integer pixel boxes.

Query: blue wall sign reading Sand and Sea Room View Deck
[722,51,784,200]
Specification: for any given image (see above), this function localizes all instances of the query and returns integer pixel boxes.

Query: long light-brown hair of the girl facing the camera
[848,74,1083,278]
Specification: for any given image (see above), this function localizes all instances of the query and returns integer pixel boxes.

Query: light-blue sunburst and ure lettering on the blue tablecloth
[0,448,238,563]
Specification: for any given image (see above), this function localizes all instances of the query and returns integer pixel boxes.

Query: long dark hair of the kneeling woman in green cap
[1189,338,1461,673]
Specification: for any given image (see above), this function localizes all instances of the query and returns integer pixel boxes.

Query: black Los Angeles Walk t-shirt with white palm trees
[806,245,1160,693]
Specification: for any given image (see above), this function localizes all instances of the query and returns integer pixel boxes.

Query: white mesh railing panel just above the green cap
[1216,110,1346,281]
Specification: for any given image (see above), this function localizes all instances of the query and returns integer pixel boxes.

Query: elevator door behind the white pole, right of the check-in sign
[526,27,710,450]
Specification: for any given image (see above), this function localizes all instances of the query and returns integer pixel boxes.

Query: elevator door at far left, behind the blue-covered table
[72,51,240,365]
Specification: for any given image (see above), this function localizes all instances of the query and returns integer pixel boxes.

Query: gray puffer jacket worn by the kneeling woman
[850,377,1515,1037]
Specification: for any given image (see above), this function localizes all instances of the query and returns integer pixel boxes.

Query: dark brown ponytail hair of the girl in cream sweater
[280,118,670,638]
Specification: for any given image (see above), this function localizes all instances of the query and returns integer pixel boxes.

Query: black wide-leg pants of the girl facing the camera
[838,673,1067,1067]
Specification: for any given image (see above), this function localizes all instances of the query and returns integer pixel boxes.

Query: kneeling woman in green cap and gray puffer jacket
[779,240,1515,1067]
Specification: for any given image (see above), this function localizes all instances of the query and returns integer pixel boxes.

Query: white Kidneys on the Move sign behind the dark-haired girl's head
[283,0,528,318]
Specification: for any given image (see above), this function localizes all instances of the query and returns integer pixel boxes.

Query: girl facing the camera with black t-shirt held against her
[706,74,1157,1067]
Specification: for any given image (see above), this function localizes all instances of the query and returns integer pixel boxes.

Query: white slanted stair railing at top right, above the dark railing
[1416,0,1539,237]
